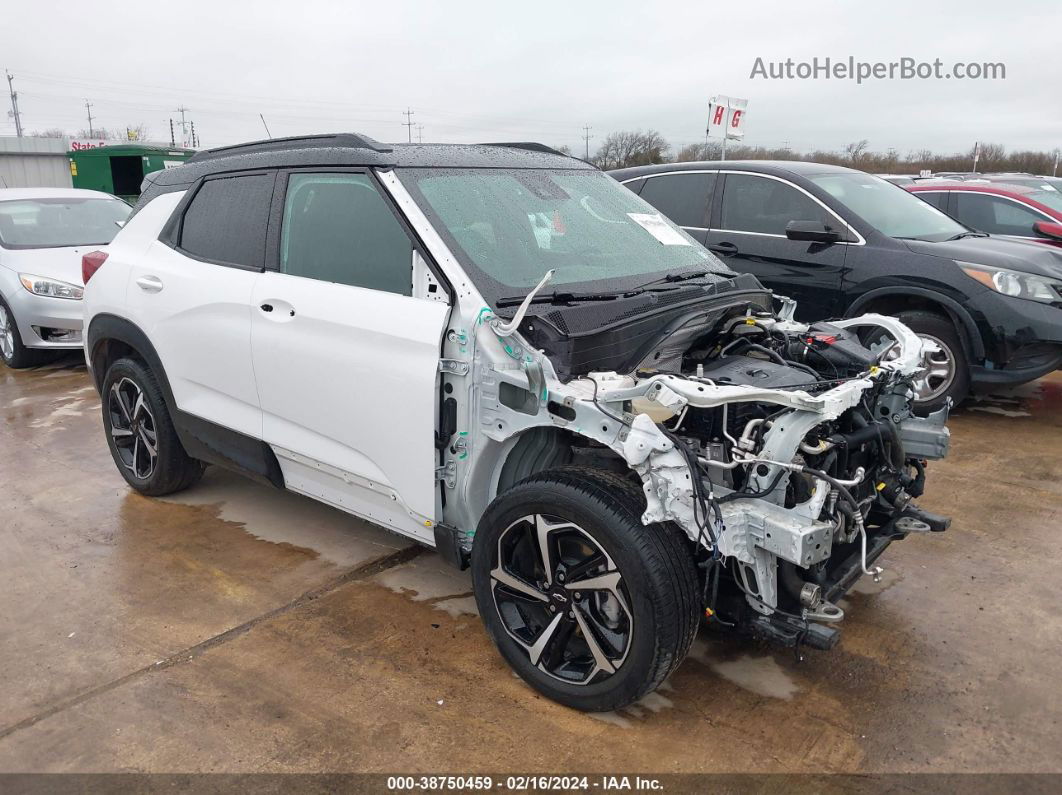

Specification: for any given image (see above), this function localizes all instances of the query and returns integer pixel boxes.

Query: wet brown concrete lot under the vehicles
[0,357,1062,773]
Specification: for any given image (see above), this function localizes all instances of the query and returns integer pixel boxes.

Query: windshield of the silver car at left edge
[0,198,132,248]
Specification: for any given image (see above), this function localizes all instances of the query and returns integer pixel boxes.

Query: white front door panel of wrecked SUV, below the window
[251,272,449,539]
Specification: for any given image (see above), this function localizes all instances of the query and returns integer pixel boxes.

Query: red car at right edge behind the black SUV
[905,182,1062,247]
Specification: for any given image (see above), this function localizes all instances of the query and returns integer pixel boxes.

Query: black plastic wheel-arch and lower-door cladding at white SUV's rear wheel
[85,314,285,488]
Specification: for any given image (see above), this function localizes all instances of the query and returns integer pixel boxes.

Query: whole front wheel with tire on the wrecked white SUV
[472,467,700,712]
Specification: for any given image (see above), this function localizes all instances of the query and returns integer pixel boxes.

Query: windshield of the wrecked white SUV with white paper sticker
[399,169,733,303]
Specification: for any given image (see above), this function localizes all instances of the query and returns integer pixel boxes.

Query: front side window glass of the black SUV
[719,174,838,237]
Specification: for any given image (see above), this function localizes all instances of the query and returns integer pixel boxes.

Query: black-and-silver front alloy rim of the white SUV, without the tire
[491,514,634,685]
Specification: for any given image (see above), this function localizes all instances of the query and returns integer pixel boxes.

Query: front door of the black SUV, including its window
[707,172,847,319]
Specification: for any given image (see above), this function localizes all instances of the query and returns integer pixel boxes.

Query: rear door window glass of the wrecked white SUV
[179,174,274,269]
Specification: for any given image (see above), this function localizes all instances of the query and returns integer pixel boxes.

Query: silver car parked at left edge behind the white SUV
[0,188,131,367]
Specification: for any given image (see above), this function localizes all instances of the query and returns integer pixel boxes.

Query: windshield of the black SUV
[810,174,969,242]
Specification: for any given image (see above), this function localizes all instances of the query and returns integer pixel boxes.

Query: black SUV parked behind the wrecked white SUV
[612,160,1062,411]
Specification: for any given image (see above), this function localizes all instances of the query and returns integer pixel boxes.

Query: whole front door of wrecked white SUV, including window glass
[251,171,449,539]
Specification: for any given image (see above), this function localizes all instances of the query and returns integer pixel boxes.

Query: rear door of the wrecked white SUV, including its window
[126,171,276,438]
